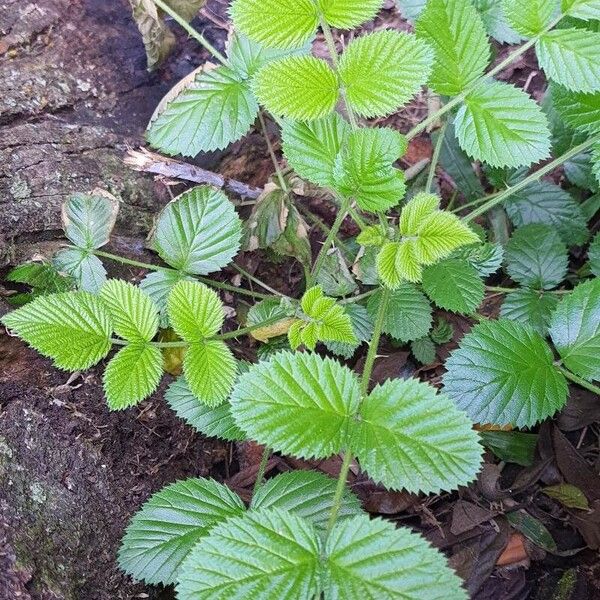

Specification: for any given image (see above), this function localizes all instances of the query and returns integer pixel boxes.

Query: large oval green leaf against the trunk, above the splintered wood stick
[146,67,258,156]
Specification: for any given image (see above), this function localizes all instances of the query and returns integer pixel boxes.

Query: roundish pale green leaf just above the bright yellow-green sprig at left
[152,186,241,275]
